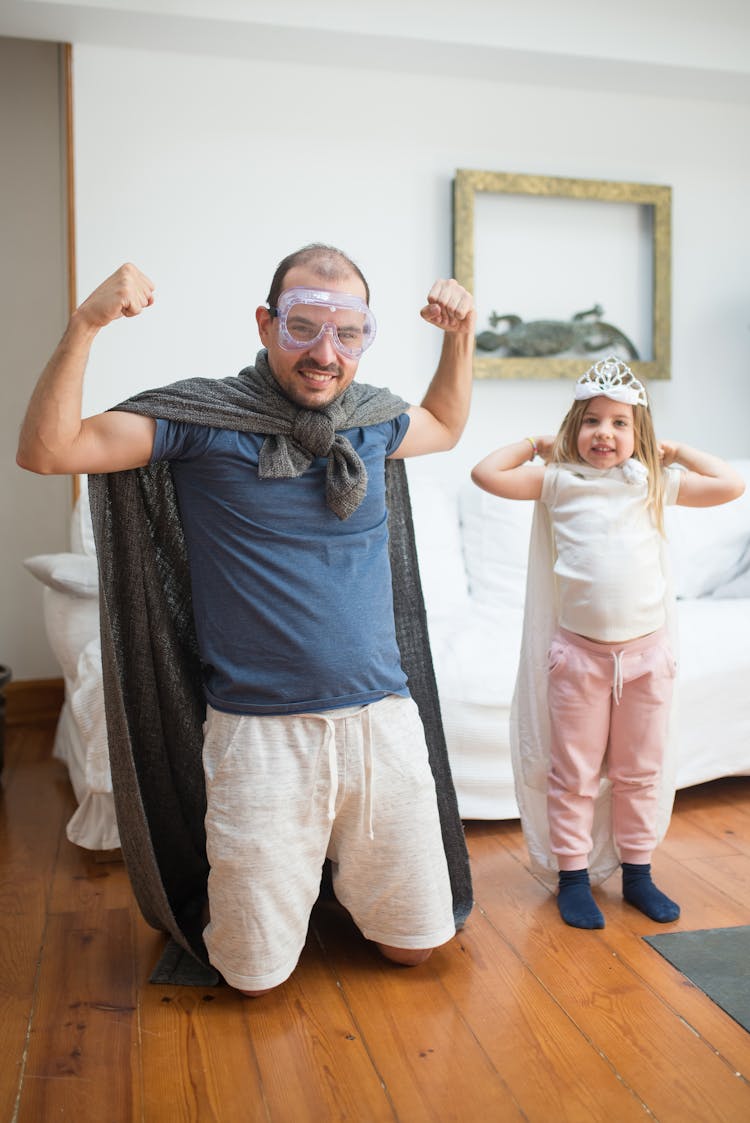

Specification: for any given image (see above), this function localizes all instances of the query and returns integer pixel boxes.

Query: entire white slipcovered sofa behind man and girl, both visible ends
[20,460,750,850]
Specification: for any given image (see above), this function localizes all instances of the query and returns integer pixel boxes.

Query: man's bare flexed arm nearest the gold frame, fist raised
[394,280,475,458]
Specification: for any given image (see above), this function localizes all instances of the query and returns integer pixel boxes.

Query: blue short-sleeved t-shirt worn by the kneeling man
[152,413,409,714]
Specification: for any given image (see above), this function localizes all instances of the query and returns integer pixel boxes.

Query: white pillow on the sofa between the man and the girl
[459,483,533,611]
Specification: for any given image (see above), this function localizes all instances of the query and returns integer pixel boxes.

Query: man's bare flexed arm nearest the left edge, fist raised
[16,265,155,475]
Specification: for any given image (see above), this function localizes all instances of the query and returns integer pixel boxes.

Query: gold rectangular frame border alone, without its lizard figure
[454,168,671,380]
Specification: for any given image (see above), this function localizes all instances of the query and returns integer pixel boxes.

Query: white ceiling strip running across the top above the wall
[0,0,750,101]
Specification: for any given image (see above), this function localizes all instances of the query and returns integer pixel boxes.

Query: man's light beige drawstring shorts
[203,695,456,990]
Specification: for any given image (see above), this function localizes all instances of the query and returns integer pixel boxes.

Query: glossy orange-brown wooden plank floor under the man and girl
[0,727,750,1123]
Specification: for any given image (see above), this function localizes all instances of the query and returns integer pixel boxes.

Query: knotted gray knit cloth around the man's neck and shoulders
[116,350,409,519]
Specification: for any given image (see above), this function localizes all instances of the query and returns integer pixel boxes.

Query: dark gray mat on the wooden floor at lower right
[643,924,750,1033]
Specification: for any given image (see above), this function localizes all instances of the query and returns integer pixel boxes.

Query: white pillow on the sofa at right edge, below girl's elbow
[665,460,750,599]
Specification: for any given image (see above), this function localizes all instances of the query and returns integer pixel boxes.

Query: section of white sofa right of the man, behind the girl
[410,460,750,819]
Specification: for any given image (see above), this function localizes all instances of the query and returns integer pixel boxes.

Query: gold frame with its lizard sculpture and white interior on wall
[454,170,671,380]
